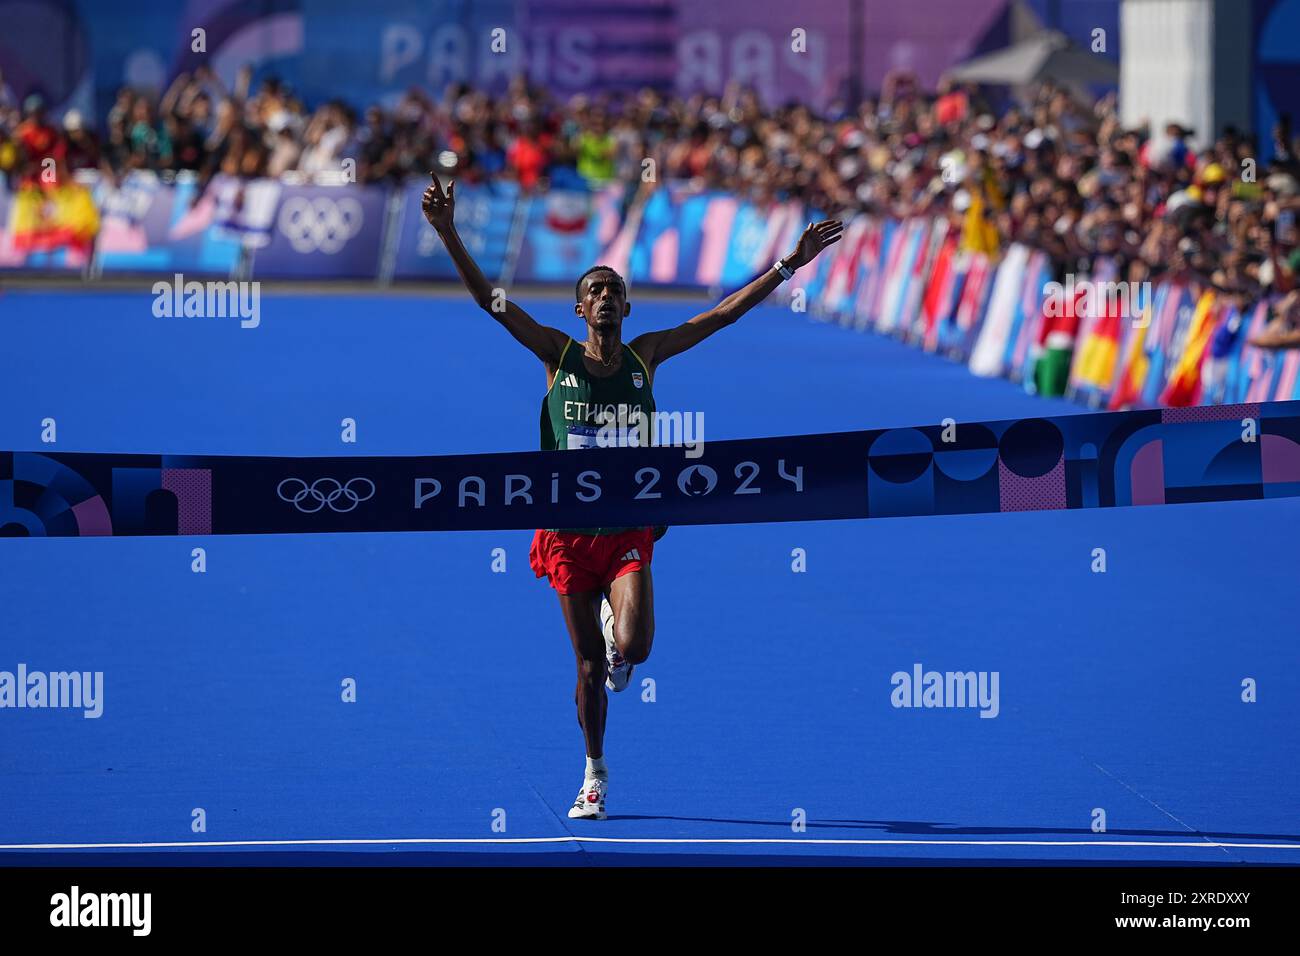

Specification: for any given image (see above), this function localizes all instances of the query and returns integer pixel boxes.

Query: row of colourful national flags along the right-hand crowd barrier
[792,217,1300,411]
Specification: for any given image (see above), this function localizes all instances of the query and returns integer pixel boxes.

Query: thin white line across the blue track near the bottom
[0,836,1300,851]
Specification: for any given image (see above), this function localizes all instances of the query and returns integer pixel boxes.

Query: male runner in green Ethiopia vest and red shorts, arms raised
[423,176,844,819]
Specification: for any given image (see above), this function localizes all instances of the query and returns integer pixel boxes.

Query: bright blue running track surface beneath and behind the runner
[0,289,1300,865]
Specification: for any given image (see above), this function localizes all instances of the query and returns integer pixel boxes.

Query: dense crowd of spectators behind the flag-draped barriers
[0,60,1300,345]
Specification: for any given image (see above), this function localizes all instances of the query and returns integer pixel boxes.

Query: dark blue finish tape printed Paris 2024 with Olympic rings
[0,402,1300,537]
